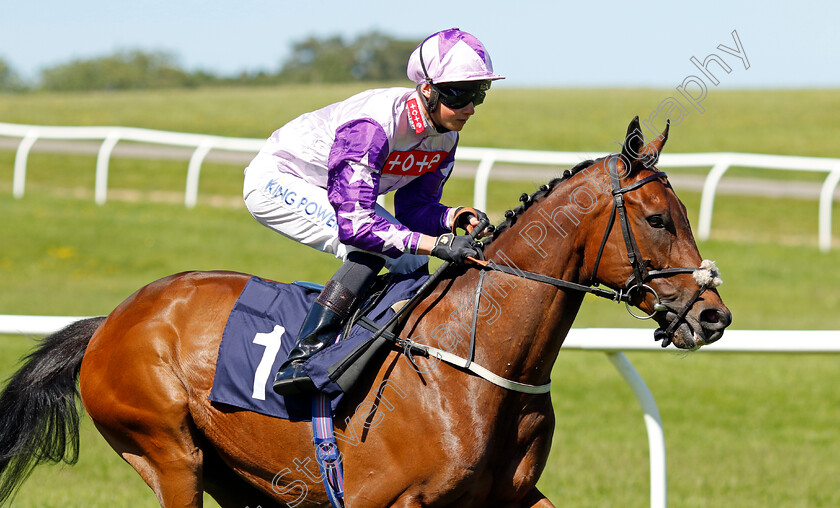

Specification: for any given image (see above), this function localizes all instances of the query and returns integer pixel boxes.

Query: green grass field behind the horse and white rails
[0,86,840,508]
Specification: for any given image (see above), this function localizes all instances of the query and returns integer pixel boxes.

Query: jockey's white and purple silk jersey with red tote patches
[254,88,458,257]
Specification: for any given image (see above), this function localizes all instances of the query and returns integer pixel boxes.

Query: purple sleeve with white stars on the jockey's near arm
[327,119,420,257]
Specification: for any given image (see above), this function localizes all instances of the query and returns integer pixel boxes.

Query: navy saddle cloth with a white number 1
[210,274,428,420]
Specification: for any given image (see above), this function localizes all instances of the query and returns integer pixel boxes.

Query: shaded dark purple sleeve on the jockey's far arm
[394,147,455,236]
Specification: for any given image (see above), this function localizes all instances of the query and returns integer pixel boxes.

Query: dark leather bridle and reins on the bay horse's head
[474,154,720,347]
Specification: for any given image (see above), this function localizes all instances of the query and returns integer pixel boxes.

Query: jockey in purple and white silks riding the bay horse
[243,28,504,395]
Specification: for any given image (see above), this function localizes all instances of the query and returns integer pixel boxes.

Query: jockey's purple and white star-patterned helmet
[406,28,505,85]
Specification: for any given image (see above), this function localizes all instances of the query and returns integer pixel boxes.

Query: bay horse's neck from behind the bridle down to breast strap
[406,181,594,384]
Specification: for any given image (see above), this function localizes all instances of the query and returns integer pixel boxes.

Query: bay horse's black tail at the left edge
[0,317,105,505]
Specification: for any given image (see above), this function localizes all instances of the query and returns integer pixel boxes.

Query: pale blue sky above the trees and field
[0,0,840,88]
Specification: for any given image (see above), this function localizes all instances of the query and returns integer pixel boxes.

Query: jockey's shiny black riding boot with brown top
[273,251,385,395]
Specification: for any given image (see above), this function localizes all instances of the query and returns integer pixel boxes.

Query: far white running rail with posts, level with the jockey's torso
[0,123,840,252]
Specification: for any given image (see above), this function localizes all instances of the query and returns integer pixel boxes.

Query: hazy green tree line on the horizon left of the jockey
[0,31,418,92]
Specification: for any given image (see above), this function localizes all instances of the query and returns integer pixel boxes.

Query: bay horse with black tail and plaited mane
[0,118,731,508]
